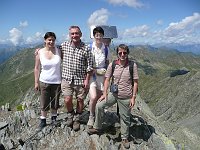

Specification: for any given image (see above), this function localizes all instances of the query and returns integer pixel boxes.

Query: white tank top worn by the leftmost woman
[39,48,61,84]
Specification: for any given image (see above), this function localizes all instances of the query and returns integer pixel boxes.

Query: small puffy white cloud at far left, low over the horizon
[9,28,23,45]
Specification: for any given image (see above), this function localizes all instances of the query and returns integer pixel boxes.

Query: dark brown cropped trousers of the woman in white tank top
[40,82,61,111]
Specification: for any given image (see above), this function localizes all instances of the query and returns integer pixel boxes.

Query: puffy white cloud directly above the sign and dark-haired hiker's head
[88,8,109,26]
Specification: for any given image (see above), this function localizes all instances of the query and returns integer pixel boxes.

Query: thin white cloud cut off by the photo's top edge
[108,0,144,8]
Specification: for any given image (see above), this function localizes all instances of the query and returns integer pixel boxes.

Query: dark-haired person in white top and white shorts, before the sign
[87,26,110,128]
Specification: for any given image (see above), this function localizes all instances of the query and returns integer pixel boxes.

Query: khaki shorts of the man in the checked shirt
[61,79,87,99]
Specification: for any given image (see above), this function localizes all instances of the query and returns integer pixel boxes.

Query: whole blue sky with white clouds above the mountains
[0,0,200,45]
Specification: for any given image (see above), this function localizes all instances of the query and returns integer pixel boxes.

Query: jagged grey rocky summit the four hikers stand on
[0,93,191,150]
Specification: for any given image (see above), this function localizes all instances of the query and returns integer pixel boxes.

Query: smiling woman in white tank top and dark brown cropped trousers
[34,32,61,129]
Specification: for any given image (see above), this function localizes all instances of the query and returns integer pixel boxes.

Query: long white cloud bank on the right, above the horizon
[117,13,200,45]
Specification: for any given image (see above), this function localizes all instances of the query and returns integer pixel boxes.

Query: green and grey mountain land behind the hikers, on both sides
[0,46,200,147]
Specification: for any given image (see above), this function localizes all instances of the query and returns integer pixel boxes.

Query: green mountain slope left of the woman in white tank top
[0,49,34,105]
